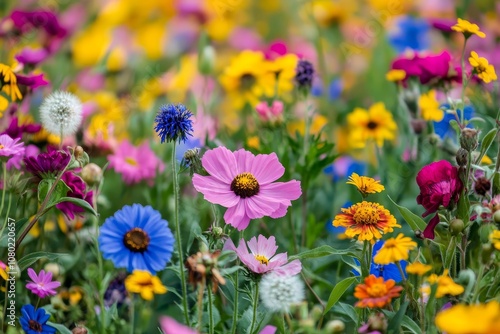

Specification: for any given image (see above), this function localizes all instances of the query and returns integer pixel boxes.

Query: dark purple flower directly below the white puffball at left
[24,149,71,180]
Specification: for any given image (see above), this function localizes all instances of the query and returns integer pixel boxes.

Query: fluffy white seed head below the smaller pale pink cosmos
[259,273,305,312]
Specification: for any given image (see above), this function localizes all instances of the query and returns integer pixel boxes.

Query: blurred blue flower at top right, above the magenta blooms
[389,16,429,53]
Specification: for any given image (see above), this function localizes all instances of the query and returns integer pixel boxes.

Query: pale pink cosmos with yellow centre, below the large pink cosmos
[224,235,302,276]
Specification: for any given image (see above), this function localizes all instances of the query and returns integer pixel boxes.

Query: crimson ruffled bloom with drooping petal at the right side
[417,160,463,239]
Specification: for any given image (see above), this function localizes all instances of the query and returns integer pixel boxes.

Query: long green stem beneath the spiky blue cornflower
[172,141,191,327]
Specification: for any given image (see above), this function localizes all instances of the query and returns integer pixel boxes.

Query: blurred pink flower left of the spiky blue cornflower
[108,140,165,185]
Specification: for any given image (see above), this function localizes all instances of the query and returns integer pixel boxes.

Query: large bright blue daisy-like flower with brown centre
[98,204,175,275]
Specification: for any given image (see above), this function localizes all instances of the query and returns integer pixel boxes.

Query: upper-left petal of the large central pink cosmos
[201,146,238,184]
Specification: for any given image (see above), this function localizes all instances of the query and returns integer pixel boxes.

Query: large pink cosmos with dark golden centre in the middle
[193,147,302,231]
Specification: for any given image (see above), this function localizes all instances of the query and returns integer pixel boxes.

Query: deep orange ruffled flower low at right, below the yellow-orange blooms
[354,275,403,308]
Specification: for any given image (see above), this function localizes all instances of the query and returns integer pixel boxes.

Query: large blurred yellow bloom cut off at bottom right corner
[436,301,500,334]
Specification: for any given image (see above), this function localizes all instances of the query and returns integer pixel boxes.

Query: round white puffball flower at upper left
[40,91,83,140]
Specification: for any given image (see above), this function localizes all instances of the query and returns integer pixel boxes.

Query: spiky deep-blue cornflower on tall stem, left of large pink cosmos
[155,103,193,143]
